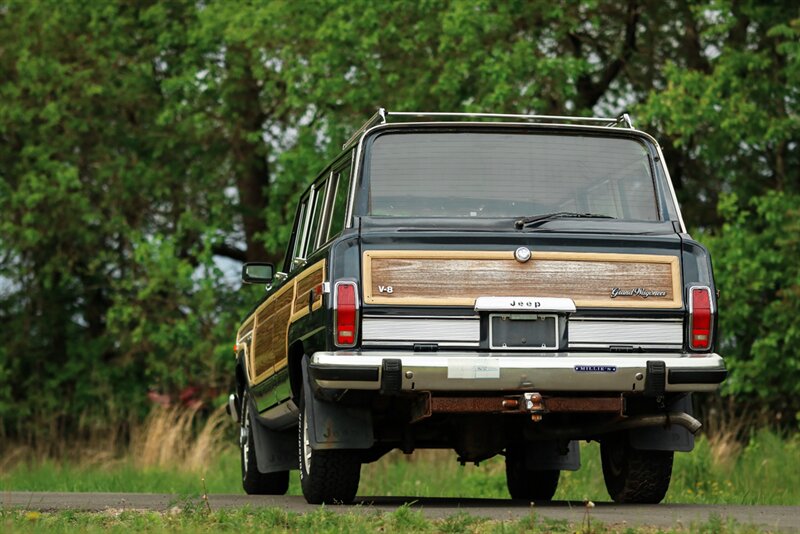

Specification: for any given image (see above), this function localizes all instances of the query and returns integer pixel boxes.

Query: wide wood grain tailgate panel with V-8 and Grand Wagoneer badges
[363,250,682,308]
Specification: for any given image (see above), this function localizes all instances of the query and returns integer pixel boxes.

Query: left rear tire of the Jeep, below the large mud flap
[297,394,361,504]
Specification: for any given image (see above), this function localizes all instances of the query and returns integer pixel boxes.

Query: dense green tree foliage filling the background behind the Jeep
[0,0,800,440]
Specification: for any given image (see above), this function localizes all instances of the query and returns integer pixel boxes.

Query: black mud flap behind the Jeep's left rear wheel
[302,358,375,450]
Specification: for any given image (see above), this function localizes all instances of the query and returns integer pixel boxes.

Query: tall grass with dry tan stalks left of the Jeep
[0,406,241,494]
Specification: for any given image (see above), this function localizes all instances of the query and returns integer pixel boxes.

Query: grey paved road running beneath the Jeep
[0,492,800,531]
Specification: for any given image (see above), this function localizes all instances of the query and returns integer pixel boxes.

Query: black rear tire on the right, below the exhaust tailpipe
[600,432,675,504]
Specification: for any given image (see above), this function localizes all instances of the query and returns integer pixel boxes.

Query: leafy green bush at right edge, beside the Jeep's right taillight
[701,191,800,425]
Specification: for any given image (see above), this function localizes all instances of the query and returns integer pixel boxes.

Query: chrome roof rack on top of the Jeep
[342,108,633,149]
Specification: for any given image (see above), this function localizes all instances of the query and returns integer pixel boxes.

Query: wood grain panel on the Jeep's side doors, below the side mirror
[250,282,294,382]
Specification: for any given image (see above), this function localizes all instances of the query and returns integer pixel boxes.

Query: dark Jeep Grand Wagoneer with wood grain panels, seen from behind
[225,110,726,503]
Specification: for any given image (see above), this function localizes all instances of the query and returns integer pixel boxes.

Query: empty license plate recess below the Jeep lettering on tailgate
[489,313,559,350]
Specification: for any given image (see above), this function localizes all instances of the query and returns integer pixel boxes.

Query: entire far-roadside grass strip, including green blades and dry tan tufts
[0,408,800,505]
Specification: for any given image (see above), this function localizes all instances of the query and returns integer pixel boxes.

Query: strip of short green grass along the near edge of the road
[0,506,759,534]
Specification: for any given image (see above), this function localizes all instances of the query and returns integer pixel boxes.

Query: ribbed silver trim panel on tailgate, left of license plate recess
[361,317,481,342]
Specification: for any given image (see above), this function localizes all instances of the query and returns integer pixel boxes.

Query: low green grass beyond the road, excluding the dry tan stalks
[0,431,800,505]
